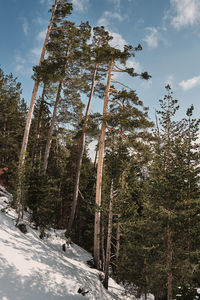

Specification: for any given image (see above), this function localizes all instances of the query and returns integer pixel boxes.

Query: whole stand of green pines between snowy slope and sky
[0,0,200,300]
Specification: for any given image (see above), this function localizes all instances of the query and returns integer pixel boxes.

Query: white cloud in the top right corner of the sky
[170,0,200,29]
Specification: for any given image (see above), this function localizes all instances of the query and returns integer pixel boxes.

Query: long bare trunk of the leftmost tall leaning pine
[16,0,59,220]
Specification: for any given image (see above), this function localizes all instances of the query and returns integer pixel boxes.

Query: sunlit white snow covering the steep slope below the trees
[0,195,153,300]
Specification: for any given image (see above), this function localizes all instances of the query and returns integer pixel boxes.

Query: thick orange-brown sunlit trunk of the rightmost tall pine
[94,59,114,269]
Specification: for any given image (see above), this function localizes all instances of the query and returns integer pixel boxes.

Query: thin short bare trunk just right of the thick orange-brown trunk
[103,181,114,289]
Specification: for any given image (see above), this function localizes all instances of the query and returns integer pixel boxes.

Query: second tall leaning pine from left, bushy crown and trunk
[35,21,90,171]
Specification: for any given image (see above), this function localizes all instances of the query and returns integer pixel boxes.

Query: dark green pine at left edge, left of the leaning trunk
[0,69,26,191]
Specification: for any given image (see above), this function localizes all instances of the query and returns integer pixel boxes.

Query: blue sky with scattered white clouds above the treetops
[0,0,200,120]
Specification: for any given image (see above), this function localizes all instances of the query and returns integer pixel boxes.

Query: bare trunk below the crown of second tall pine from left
[43,81,63,173]
